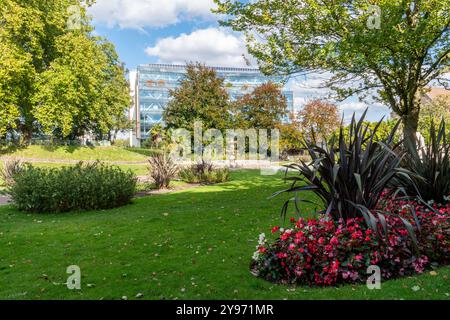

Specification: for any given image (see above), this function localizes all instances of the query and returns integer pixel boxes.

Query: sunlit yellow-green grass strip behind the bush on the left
[0,146,151,162]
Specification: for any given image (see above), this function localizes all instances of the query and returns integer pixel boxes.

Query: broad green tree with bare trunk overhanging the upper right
[215,0,450,146]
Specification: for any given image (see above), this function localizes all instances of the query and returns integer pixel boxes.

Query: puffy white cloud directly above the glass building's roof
[146,28,256,67]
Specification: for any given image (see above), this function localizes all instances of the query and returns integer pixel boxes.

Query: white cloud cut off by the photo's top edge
[89,0,215,30]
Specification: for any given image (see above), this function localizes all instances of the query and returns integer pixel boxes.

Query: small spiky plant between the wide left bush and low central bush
[148,153,178,189]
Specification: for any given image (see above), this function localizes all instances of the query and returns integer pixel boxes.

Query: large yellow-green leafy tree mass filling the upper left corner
[0,0,129,141]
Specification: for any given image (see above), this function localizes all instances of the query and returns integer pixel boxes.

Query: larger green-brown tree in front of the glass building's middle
[163,63,231,131]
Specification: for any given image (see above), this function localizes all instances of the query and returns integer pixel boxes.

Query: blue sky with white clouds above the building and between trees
[89,0,389,120]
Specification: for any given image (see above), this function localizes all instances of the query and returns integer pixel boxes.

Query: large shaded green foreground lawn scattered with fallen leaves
[0,171,450,299]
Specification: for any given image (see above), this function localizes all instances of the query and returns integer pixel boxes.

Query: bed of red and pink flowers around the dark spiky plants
[252,200,450,286]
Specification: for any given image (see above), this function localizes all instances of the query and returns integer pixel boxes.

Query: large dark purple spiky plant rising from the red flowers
[274,110,411,231]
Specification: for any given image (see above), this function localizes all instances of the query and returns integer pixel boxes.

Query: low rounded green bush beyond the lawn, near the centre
[179,161,230,183]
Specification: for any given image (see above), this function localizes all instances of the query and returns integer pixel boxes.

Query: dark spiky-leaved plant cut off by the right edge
[404,121,450,203]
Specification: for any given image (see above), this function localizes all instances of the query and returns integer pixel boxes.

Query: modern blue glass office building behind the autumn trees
[130,64,294,146]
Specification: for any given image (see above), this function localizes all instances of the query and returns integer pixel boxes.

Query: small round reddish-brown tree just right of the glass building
[298,99,341,141]
